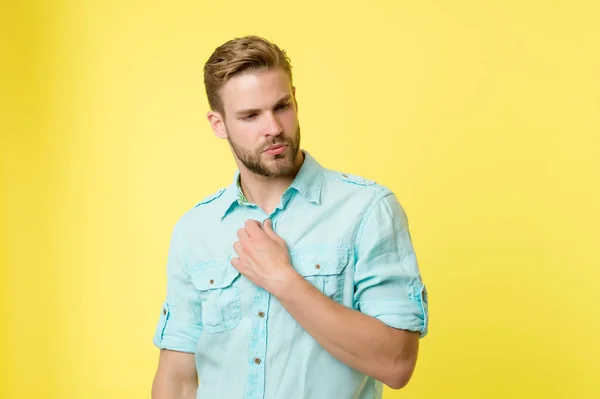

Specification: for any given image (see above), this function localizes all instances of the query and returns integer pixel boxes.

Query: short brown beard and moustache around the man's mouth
[227,125,300,177]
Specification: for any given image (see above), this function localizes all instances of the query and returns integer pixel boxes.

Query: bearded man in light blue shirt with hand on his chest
[152,36,428,399]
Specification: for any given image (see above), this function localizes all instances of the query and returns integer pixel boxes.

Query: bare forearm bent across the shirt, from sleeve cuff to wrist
[273,275,418,389]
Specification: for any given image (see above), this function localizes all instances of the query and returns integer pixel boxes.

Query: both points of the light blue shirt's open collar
[220,150,323,219]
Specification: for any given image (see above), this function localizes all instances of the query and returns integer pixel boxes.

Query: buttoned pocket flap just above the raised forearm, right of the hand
[290,247,348,277]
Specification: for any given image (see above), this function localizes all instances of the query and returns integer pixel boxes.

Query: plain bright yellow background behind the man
[0,0,600,399]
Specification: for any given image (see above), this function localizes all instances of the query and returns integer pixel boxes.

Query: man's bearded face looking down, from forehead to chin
[221,68,300,177]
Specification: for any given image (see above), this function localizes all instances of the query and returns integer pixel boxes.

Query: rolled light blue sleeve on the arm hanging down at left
[153,221,202,353]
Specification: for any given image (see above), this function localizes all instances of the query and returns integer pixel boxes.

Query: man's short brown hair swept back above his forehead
[204,35,292,115]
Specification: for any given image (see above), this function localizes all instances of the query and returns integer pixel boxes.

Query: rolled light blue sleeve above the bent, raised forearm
[354,192,428,338]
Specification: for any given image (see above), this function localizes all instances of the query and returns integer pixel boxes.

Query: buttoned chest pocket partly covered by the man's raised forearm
[290,246,349,302]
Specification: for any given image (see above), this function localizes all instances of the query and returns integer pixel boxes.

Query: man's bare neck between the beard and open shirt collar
[239,151,304,215]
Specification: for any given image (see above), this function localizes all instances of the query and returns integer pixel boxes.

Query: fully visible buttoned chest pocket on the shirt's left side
[191,261,242,334]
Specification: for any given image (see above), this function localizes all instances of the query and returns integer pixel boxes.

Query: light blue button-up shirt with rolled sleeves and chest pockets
[153,151,428,399]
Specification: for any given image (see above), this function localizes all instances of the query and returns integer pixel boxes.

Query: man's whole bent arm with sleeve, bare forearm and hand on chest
[232,193,428,389]
